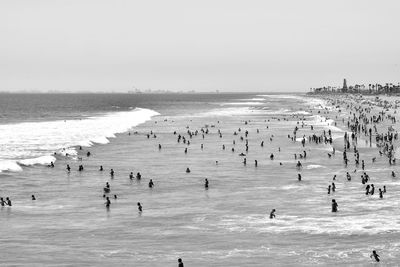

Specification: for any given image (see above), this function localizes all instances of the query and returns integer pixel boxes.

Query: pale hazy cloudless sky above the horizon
[0,0,400,91]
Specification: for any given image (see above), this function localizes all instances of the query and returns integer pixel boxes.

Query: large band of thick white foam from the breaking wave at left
[0,108,159,174]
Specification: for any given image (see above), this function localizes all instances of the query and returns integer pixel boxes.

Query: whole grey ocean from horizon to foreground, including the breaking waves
[0,93,400,266]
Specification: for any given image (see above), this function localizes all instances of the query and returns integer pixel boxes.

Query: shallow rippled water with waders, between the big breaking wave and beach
[0,95,400,266]
